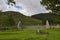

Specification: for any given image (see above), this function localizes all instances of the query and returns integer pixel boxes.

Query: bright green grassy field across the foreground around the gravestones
[0,29,60,40]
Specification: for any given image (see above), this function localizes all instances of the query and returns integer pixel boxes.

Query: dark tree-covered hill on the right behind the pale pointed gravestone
[32,13,60,25]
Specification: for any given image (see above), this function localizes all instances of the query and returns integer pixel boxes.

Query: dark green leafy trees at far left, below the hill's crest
[0,14,15,26]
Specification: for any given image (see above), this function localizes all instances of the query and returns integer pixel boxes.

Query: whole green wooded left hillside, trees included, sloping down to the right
[0,11,41,26]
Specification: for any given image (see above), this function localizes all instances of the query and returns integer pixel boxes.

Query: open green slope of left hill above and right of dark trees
[0,11,41,26]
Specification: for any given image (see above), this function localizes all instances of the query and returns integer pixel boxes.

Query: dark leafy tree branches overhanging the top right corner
[41,0,60,13]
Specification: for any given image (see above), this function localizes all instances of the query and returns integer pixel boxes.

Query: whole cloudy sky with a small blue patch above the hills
[0,0,48,16]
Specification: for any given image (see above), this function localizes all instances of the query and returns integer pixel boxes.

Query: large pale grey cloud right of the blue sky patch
[16,0,47,15]
